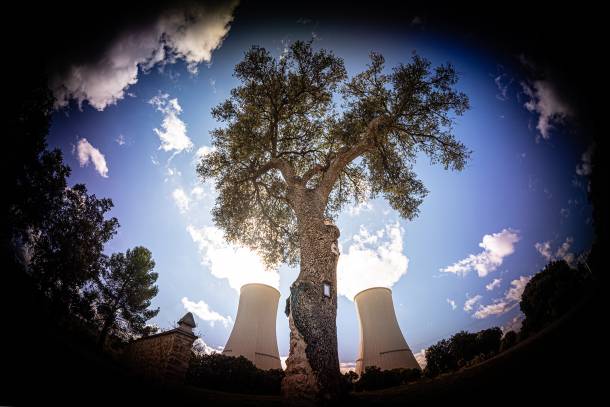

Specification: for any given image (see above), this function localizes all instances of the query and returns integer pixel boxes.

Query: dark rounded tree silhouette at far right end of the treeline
[519,260,592,337]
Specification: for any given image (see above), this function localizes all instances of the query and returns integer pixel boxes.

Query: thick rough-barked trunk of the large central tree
[282,190,341,403]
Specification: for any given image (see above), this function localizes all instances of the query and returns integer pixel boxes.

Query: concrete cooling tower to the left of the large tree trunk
[222,284,282,370]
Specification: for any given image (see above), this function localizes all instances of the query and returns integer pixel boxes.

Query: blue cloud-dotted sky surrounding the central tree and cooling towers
[48,3,592,369]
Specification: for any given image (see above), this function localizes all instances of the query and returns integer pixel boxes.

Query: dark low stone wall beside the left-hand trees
[125,328,197,382]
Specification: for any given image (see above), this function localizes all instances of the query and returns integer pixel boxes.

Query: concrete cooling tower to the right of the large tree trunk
[354,287,420,375]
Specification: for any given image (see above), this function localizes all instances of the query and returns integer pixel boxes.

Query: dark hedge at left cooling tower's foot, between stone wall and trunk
[186,353,284,394]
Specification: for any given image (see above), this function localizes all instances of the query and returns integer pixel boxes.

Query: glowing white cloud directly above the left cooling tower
[187,225,280,293]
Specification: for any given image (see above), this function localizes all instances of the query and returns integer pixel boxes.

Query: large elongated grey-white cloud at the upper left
[51,1,237,111]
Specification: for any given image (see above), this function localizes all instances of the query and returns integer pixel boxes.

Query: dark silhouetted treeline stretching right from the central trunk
[343,254,595,391]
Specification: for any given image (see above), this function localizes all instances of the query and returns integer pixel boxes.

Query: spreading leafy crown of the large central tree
[197,41,469,265]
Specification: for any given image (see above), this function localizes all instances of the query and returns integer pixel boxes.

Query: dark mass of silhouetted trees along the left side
[2,79,159,352]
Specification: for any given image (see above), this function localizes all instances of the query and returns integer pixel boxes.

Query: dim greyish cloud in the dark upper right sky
[521,80,573,140]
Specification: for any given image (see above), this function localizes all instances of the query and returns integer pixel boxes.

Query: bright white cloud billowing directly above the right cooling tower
[337,222,409,301]
